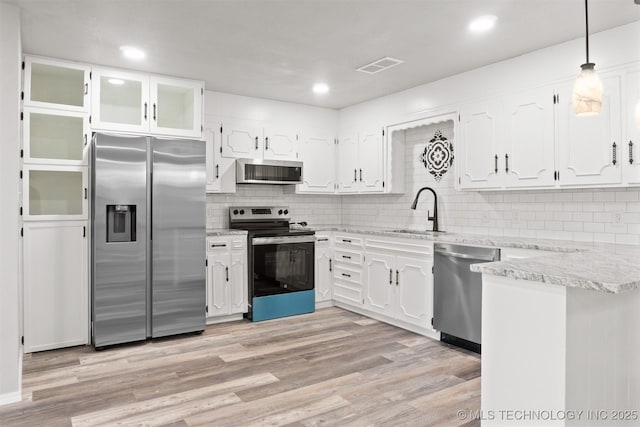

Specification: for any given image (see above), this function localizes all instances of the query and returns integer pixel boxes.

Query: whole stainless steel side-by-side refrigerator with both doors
[91,133,206,348]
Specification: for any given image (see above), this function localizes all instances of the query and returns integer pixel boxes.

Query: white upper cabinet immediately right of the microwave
[297,133,336,194]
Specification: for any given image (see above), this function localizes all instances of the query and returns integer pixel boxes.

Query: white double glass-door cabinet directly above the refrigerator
[91,67,203,139]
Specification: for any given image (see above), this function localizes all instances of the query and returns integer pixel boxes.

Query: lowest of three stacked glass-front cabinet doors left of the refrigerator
[22,165,89,221]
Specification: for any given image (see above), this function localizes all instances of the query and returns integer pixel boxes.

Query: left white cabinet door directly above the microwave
[222,119,264,159]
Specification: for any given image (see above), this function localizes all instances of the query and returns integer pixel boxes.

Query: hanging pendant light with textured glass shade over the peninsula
[573,0,603,116]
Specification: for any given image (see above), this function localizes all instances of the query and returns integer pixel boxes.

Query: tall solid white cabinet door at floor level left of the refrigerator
[24,221,89,353]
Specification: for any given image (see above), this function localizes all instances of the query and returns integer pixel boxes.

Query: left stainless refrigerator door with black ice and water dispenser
[91,134,147,347]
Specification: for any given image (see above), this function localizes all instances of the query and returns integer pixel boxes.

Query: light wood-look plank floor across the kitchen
[0,307,480,427]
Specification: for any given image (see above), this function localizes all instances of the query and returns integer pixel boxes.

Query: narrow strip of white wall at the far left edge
[0,3,22,405]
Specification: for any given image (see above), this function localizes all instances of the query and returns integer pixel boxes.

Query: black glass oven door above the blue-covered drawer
[250,235,315,298]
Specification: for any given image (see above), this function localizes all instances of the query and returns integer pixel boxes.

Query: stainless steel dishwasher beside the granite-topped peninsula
[433,243,500,353]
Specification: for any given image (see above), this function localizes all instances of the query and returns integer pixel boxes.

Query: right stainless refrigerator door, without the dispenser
[151,138,206,337]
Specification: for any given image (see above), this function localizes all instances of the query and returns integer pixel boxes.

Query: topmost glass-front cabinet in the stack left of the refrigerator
[24,56,91,112]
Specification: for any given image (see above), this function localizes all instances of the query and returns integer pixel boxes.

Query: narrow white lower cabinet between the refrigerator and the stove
[207,235,248,321]
